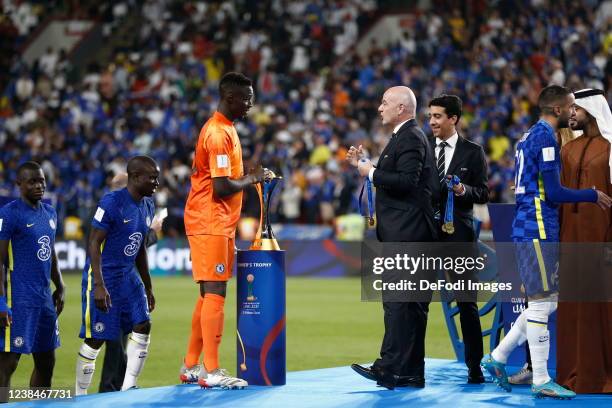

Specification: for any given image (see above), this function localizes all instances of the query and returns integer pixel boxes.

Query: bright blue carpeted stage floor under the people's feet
[9,359,612,408]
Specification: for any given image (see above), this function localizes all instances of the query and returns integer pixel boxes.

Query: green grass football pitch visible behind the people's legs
[11,275,488,393]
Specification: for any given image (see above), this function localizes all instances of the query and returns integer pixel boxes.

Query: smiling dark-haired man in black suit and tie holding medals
[429,95,489,384]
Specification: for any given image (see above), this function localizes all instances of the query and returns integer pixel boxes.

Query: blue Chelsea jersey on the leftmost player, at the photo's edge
[0,199,57,306]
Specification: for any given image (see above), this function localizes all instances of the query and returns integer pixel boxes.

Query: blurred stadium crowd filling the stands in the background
[0,0,612,236]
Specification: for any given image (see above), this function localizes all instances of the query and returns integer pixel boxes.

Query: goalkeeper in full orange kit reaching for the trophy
[180,72,269,389]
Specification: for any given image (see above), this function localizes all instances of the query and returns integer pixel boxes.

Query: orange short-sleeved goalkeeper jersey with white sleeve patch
[185,112,243,238]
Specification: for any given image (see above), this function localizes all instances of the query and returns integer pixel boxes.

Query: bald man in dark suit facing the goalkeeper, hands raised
[347,86,436,389]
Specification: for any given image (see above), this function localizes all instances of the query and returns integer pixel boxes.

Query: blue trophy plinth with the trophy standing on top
[236,168,287,386]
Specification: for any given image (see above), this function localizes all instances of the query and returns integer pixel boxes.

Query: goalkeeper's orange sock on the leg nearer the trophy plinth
[200,293,225,372]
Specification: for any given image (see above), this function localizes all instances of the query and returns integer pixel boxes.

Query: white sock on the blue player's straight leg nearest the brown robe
[525,299,557,385]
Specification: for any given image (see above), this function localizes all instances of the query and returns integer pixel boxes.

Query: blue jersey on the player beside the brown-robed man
[512,120,561,241]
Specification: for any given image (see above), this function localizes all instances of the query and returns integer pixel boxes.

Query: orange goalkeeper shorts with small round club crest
[187,235,235,282]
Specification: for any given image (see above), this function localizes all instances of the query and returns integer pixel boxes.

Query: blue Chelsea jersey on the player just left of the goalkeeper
[84,188,155,280]
